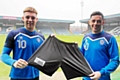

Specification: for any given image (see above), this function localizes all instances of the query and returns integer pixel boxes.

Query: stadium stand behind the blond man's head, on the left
[0,16,75,34]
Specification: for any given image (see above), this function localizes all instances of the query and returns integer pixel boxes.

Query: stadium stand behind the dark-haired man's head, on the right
[79,13,120,35]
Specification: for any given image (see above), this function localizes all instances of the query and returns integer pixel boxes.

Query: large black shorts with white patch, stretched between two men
[28,36,93,80]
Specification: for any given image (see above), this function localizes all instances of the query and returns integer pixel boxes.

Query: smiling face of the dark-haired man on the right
[89,15,104,34]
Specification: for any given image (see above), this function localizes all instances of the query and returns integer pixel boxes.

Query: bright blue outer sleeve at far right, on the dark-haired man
[100,37,119,75]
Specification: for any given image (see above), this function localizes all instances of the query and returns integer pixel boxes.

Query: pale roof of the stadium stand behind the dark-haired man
[79,13,120,24]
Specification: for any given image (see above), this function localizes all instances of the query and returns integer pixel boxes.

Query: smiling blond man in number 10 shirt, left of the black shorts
[1,7,44,80]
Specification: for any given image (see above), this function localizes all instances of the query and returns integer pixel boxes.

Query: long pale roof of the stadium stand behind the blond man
[0,16,75,24]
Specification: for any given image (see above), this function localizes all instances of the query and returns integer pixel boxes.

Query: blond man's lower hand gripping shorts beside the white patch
[13,59,28,69]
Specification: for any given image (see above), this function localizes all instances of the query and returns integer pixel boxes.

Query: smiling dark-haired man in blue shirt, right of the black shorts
[80,11,119,80]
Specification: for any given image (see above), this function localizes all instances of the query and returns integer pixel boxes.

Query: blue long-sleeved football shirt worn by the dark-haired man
[81,31,119,80]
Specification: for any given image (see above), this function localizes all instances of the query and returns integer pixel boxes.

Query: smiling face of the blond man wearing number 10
[22,12,38,31]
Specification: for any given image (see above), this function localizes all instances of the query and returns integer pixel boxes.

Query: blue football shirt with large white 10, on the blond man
[2,28,44,79]
